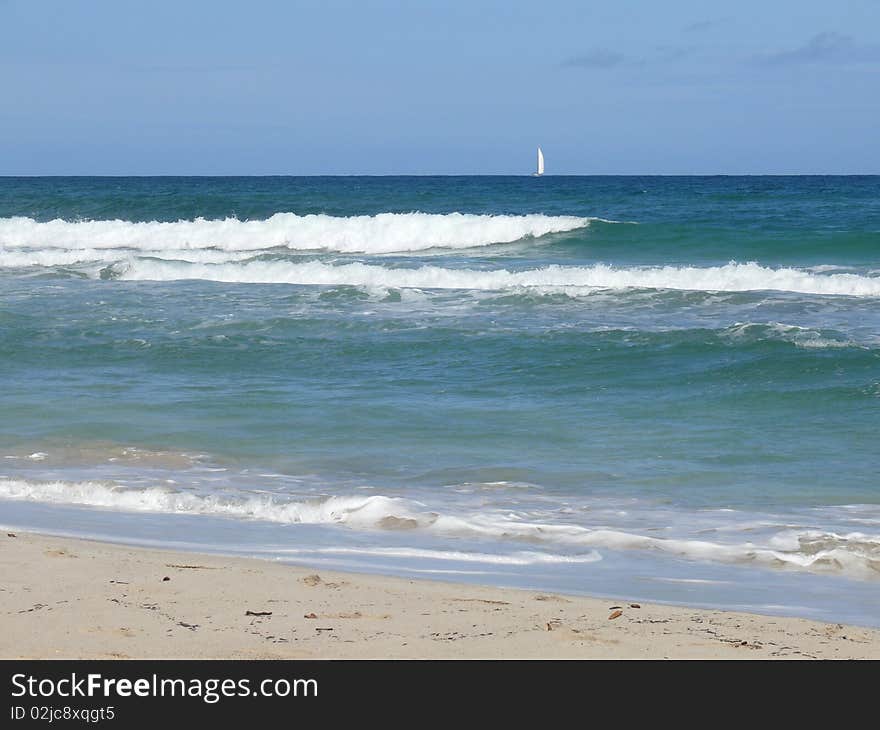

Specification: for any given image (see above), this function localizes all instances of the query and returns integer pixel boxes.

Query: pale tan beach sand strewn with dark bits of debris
[0,533,880,659]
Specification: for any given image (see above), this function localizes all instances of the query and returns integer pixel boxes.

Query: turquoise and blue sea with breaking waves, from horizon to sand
[0,177,880,625]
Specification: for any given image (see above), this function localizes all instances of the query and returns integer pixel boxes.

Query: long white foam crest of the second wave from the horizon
[111,261,880,297]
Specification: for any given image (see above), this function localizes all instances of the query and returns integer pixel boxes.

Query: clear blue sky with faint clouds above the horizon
[0,0,880,175]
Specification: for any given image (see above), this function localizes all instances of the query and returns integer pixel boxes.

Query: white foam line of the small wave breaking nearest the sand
[0,478,880,579]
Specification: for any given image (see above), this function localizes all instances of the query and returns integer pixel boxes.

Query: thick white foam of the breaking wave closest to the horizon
[0,213,590,253]
